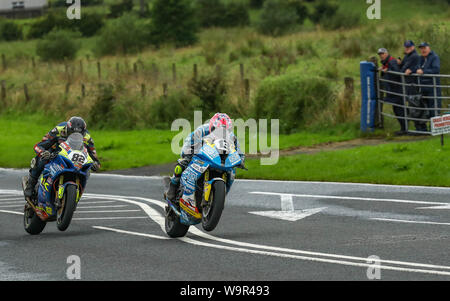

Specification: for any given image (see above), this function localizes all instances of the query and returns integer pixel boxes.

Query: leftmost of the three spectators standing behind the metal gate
[378,48,407,136]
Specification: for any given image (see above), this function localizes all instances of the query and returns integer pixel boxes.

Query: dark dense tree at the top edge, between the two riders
[151,0,198,47]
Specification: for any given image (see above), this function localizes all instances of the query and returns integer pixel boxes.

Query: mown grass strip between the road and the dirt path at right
[237,138,450,186]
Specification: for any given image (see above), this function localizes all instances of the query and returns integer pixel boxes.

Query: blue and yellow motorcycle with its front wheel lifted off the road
[165,130,246,238]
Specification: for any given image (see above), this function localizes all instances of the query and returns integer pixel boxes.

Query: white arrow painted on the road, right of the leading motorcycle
[249,194,327,222]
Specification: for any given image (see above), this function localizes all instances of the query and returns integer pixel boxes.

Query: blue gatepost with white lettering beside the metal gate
[360,62,377,132]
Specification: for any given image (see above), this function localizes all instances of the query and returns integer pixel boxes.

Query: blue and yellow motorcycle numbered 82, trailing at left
[22,133,94,235]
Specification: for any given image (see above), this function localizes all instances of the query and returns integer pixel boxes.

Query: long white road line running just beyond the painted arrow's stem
[249,191,449,205]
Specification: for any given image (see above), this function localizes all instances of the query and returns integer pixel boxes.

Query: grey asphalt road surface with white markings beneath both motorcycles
[0,169,450,281]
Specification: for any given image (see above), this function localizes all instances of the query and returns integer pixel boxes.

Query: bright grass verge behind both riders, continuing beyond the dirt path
[0,114,358,171]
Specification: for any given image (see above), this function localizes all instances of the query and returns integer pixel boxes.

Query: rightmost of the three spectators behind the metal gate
[417,42,442,118]
